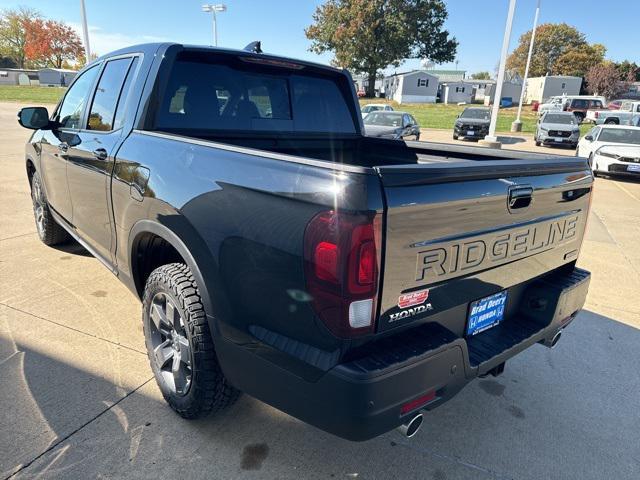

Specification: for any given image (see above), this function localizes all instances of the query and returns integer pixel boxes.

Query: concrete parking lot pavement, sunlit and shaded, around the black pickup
[0,99,640,480]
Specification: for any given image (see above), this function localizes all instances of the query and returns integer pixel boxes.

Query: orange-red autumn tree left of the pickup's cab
[25,19,83,68]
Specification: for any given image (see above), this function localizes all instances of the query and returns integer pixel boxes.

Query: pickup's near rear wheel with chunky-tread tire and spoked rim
[142,263,240,419]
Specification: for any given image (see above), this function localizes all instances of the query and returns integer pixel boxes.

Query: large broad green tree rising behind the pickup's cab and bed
[305,0,458,96]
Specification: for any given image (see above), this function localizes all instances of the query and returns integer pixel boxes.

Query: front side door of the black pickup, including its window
[40,65,100,222]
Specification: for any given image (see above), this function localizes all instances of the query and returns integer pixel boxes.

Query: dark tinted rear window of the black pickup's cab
[155,57,356,134]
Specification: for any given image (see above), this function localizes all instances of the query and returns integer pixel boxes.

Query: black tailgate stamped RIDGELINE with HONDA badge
[377,157,593,335]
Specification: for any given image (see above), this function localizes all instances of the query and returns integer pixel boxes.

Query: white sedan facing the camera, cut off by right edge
[576,125,640,177]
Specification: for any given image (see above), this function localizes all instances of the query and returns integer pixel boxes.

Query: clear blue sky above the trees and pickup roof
[0,0,640,73]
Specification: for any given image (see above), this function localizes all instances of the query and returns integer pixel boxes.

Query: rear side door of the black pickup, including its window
[67,56,137,264]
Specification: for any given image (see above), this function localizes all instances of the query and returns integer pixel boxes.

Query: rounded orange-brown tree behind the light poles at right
[507,23,604,77]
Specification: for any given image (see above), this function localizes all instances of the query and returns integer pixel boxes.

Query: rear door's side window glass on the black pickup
[87,57,132,132]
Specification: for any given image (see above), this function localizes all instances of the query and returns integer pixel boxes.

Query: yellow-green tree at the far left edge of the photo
[0,7,41,68]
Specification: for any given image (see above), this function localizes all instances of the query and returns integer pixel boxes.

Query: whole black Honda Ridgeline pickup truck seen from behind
[19,43,593,440]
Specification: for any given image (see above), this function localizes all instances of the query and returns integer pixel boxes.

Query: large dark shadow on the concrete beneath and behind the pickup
[5,311,640,480]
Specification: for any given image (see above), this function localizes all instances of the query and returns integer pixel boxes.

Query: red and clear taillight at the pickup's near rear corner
[304,210,381,337]
